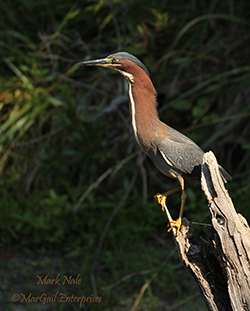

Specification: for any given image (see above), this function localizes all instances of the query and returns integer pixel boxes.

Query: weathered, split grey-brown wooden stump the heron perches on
[173,151,250,311]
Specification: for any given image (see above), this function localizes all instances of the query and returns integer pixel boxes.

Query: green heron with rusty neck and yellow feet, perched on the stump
[76,52,231,235]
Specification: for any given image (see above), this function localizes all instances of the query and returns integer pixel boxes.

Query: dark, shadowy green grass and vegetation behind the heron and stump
[0,0,250,310]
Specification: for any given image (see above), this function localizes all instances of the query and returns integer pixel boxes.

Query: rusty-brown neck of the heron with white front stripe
[129,78,160,152]
